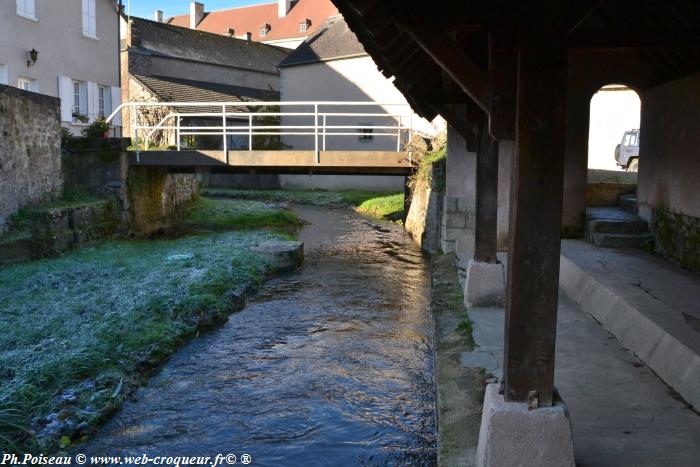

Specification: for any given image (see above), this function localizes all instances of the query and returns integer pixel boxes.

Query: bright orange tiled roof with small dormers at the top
[168,0,338,42]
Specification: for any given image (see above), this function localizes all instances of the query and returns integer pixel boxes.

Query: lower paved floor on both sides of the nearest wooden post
[463,292,700,467]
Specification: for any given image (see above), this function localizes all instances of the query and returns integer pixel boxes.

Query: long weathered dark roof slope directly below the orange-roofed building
[131,18,289,75]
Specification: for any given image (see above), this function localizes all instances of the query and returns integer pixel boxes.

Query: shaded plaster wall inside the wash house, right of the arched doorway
[637,73,700,271]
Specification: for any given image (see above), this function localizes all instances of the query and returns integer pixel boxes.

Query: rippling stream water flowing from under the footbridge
[82,206,436,466]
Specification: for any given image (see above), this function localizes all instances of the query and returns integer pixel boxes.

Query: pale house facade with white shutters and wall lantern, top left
[0,0,121,135]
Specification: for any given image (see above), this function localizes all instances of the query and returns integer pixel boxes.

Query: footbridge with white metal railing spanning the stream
[107,102,415,176]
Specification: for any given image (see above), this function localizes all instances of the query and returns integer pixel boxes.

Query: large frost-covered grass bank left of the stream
[0,200,299,453]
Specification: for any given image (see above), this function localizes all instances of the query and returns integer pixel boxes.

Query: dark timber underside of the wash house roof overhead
[333,0,700,124]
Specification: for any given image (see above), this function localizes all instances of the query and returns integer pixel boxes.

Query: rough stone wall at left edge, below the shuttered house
[0,85,63,232]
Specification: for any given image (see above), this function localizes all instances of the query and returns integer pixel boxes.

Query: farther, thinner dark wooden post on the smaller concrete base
[474,119,498,263]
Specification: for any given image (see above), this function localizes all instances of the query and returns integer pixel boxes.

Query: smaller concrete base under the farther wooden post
[464,259,506,308]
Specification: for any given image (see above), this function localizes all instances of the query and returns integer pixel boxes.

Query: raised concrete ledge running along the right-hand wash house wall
[560,240,700,410]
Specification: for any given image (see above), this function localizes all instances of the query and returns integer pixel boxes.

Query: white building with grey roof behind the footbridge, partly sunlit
[280,16,445,191]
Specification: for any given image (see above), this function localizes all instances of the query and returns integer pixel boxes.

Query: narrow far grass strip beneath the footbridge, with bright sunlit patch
[203,188,404,221]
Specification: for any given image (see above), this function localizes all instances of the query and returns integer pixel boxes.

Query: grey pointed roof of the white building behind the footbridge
[279,15,367,68]
